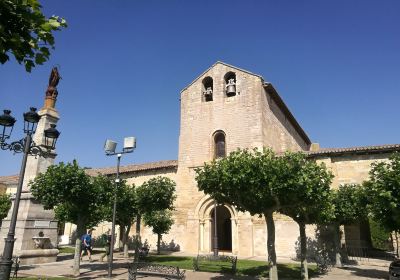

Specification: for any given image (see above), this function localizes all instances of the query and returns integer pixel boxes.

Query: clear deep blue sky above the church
[0,0,400,175]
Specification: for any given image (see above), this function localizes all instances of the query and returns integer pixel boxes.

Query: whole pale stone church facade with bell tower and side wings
[0,62,400,257]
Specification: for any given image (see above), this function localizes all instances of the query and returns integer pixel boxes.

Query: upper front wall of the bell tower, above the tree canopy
[179,64,263,168]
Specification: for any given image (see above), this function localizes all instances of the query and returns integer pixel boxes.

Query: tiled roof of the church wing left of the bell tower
[86,160,178,176]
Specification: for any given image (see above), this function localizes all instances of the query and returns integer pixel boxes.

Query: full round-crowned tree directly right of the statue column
[29,161,113,275]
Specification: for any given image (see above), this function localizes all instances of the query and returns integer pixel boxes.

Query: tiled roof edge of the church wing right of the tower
[306,144,400,157]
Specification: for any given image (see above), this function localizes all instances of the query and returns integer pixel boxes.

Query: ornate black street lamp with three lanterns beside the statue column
[0,107,60,280]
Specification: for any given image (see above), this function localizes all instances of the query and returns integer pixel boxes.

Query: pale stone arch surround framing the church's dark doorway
[195,195,238,254]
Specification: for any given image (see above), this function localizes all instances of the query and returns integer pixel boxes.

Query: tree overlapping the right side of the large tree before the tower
[279,152,333,280]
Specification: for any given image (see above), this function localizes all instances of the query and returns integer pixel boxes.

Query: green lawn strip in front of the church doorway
[146,255,318,279]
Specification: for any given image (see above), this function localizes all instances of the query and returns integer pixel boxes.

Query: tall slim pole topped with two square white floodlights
[103,137,136,280]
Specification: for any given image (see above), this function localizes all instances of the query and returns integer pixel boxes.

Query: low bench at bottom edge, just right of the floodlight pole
[128,262,185,280]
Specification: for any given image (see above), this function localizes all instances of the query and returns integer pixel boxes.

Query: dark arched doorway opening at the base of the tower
[210,205,232,252]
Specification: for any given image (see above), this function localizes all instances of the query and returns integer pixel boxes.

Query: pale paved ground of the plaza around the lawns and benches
[19,255,390,280]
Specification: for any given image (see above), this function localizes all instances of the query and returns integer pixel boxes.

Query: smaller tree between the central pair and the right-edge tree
[330,184,368,266]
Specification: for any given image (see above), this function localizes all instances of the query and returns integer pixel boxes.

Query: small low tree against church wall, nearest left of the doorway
[143,210,174,255]
